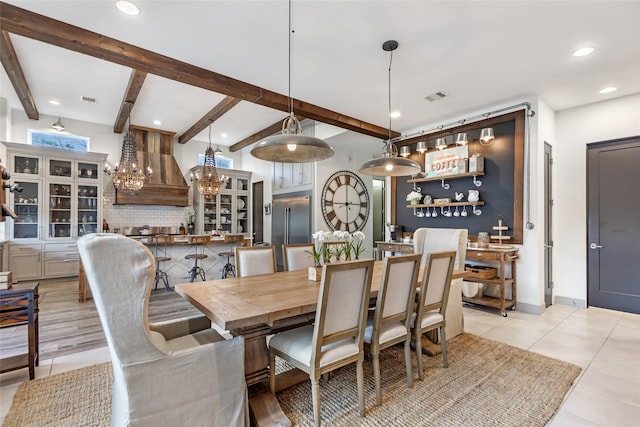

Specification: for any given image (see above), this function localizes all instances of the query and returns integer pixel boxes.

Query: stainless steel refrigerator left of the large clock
[271,191,311,271]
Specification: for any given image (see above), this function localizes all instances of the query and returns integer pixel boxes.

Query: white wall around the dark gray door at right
[553,93,640,306]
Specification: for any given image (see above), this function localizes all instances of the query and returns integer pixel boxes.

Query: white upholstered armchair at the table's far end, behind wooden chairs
[413,228,469,339]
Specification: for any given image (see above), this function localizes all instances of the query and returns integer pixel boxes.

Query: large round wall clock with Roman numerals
[320,171,371,232]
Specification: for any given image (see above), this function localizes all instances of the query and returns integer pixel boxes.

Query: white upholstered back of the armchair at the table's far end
[413,228,469,270]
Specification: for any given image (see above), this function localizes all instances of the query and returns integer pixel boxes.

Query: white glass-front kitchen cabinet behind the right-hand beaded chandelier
[191,166,251,236]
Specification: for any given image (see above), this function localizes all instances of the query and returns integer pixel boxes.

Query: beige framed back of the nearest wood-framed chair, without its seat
[311,259,373,369]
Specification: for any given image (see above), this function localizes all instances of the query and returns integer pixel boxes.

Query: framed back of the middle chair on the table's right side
[371,254,422,334]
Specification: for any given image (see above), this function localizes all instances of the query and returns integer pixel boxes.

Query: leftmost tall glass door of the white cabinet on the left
[11,180,42,239]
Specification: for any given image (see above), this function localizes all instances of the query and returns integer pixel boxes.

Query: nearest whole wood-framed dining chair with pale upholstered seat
[269,260,373,426]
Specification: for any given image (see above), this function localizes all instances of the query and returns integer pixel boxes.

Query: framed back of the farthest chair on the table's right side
[416,251,456,319]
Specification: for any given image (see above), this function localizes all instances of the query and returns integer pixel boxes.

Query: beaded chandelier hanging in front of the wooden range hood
[104,102,151,195]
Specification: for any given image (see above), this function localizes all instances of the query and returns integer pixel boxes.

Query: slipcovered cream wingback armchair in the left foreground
[78,234,249,427]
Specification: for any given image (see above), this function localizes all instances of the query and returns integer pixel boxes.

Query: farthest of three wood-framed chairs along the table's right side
[411,251,456,381]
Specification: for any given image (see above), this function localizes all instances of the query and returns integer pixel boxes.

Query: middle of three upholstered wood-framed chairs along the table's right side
[364,254,421,405]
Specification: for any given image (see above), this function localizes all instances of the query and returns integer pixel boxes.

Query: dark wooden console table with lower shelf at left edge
[0,282,40,380]
